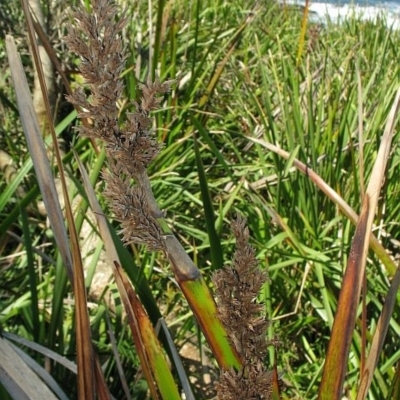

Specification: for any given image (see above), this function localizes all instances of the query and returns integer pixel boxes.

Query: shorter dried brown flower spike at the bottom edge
[213,216,272,400]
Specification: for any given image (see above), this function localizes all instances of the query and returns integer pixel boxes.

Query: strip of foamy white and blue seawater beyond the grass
[286,0,400,29]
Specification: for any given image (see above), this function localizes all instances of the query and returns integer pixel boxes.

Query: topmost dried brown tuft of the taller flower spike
[65,0,127,146]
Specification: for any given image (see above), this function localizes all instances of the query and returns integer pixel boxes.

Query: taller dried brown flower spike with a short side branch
[66,0,171,250]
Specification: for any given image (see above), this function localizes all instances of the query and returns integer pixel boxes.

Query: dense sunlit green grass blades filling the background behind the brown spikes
[0,0,400,399]
